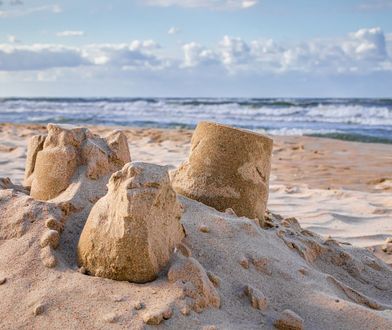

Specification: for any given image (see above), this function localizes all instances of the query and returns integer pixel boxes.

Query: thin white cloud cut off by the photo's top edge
[143,0,258,10]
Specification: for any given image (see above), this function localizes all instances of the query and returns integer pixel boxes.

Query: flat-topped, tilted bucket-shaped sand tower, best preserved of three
[172,122,273,223]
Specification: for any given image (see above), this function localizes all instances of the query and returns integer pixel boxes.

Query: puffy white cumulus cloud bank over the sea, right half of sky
[183,28,392,74]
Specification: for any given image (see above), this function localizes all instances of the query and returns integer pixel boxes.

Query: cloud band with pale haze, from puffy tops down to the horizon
[0,27,392,96]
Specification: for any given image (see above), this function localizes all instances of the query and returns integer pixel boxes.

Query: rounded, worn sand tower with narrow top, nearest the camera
[78,162,184,283]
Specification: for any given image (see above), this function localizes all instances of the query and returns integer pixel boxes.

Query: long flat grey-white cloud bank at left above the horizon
[0,40,164,71]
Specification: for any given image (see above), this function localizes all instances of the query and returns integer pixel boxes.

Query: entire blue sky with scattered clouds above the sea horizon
[0,0,392,97]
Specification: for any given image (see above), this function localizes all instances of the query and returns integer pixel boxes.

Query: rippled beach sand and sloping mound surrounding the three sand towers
[0,124,392,329]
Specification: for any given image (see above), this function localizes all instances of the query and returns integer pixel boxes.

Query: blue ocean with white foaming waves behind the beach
[0,98,392,143]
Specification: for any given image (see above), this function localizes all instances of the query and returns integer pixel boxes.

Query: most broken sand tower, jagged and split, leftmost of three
[24,124,130,200]
